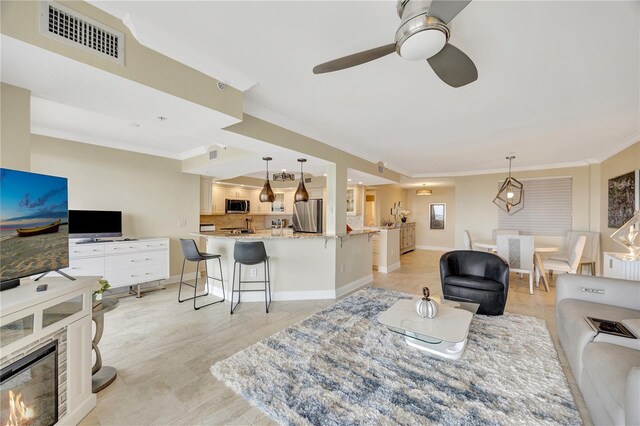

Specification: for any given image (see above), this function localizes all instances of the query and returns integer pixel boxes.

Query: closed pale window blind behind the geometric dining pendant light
[498,177,573,235]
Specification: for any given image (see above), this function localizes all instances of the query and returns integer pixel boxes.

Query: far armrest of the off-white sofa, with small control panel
[556,274,640,310]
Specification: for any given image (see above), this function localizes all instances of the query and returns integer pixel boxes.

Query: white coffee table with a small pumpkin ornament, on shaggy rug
[378,297,480,359]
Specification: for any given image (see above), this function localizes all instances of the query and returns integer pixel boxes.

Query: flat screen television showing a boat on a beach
[0,168,69,289]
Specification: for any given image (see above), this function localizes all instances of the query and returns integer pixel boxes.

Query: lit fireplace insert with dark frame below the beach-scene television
[0,340,58,426]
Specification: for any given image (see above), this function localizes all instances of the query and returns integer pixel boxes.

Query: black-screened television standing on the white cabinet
[69,210,122,241]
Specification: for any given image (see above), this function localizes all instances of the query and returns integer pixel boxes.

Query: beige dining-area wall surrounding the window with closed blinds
[455,166,598,248]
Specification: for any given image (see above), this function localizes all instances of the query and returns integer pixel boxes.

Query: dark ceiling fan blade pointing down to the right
[427,43,478,87]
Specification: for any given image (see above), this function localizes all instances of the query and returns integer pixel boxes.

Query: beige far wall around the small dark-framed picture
[407,186,456,249]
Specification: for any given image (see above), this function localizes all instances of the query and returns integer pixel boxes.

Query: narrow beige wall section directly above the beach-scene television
[0,83,31,171]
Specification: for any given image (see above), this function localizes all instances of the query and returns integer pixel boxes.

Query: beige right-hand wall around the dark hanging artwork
[599,142,640,252]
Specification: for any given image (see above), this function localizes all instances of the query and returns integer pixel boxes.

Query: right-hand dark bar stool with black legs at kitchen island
[231,241,271,314]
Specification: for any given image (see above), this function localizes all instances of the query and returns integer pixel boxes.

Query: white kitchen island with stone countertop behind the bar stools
[191,229,375,302]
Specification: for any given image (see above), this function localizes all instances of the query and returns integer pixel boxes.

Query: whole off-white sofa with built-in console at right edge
[556,274,640,425]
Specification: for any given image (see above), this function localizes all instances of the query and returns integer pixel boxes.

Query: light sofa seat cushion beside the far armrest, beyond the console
[556,299,640,384]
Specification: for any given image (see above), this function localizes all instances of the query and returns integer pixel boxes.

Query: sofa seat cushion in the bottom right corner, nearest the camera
[582,343,640,424]
